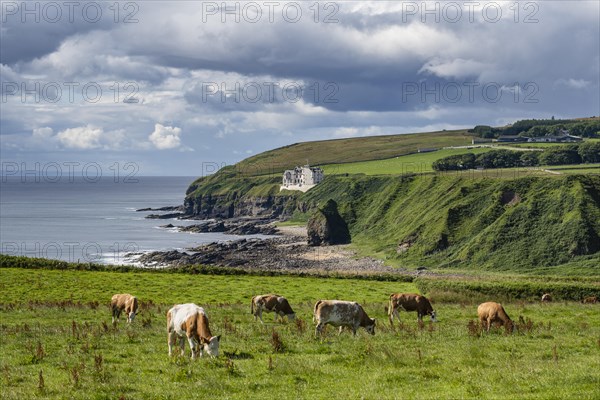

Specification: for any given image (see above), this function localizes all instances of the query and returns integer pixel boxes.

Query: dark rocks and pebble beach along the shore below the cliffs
[126,212,407,275]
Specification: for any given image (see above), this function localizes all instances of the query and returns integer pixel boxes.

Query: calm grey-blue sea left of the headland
[0,176,255,264]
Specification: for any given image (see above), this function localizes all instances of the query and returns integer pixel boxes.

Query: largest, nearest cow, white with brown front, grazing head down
[167,303,221,360]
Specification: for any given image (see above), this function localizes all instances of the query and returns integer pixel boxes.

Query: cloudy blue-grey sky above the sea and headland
[0,0,600,176]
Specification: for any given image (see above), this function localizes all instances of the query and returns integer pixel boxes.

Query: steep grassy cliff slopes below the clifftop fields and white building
[185,169,600,271]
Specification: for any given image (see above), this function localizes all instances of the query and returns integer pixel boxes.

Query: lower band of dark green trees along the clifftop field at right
[432,141,600,171]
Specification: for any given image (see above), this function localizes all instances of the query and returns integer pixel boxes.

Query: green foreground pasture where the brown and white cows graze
[0,268,600,399]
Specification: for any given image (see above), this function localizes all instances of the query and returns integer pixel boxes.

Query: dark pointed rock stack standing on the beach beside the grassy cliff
[307,199,350,246]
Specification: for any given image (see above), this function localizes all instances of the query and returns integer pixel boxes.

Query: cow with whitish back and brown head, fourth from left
[313,300,375,336]
